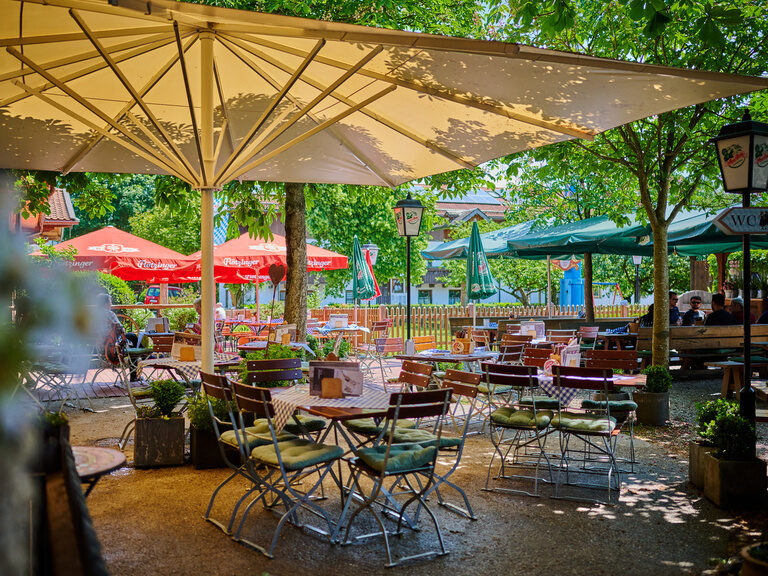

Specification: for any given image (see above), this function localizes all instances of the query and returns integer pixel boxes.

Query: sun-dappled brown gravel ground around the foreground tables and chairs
[61,376,768,576]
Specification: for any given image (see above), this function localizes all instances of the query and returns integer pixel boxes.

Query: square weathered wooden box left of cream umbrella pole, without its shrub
[133,417,184,468]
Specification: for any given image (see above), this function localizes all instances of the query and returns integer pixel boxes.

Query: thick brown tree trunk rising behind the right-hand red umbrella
[285,183,307,342]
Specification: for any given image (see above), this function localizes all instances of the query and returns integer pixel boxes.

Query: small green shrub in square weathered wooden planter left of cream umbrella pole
[133,379,185,468]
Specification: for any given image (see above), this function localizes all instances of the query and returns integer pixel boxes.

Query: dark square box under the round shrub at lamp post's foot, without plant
[704,454,768,508]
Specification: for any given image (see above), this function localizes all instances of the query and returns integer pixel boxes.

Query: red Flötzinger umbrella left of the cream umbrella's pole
[32,226,197,283]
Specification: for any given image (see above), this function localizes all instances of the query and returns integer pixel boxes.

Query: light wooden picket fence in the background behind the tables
[310,304,648,348]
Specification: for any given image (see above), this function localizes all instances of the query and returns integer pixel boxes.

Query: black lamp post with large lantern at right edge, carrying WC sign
[711,110,768,438]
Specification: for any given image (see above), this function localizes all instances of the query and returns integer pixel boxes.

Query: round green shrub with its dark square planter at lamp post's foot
[704,411,768,507]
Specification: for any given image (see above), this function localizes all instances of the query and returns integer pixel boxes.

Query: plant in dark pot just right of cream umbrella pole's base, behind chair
[187,393,237,470]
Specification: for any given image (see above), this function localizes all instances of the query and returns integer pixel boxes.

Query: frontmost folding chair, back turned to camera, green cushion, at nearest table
[339,390,451,567]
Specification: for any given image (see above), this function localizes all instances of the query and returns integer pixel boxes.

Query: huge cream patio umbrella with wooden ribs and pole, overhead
[0,0,768,371]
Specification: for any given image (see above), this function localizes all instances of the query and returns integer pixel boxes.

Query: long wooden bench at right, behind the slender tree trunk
[636,324,768,367]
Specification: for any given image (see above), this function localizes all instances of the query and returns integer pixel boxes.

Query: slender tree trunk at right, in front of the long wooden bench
[652,221,669,367]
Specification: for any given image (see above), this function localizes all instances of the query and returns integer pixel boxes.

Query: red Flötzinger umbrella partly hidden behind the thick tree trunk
[190,232,349,284]
